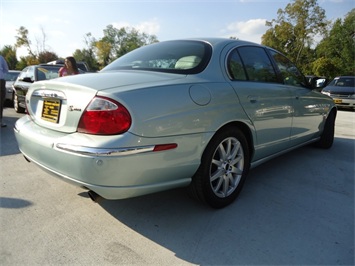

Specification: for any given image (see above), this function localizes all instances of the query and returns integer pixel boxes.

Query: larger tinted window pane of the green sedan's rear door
[238,46,277,82]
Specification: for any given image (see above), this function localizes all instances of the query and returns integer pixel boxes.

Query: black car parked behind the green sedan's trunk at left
[13,65,60,113]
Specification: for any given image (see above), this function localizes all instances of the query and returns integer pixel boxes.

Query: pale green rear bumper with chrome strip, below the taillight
[15,116,206,199]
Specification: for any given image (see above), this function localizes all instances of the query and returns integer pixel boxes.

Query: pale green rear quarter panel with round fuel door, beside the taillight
[99,80,253,137]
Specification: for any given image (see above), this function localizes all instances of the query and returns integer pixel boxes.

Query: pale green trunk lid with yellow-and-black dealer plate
[26,71,184,133]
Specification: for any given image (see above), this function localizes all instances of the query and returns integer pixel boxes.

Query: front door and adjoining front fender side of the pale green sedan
[269,49,326,145]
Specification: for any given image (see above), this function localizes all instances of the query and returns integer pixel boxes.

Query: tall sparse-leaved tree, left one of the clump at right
[262,0,329,72]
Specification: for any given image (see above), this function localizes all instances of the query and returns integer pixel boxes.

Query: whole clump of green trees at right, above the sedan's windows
[262,0,355,78]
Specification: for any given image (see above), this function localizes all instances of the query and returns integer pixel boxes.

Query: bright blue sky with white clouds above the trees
[0,0,355,57]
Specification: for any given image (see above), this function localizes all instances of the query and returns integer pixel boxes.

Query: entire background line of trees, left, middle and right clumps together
[0,0,355,78]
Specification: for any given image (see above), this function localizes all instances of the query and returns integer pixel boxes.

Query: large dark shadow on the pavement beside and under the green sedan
[92,138,354,265]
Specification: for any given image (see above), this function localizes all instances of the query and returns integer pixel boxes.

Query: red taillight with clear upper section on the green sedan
[78,97,132,135]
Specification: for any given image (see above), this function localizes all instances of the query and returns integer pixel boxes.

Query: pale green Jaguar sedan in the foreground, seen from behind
[15,38,337,208]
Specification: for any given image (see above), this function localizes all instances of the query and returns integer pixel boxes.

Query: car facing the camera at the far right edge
[322,76,355,109]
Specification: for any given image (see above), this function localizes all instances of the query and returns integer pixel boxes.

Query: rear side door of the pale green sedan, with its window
[227,46,293,160]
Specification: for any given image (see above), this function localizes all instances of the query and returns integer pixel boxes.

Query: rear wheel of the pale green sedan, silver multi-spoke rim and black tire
[190,127,250,208]
